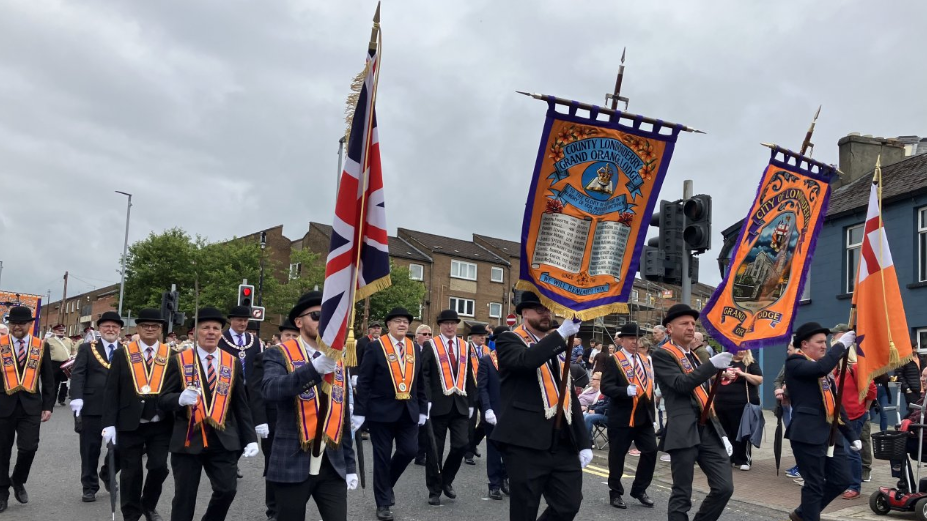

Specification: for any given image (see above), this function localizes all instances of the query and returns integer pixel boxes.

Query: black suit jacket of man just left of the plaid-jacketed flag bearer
[158,348,257,454]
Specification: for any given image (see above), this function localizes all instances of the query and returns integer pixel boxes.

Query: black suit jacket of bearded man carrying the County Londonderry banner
[490,331,592,451]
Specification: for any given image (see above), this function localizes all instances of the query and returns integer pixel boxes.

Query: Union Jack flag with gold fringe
[319,41,390,362]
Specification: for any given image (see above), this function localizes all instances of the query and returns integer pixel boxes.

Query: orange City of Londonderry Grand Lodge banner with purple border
[702,148,836,351]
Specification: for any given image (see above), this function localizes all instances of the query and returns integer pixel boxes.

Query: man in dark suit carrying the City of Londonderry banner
[652,304,734,521]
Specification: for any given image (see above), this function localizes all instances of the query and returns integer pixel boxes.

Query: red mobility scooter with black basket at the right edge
[869,404,927,521]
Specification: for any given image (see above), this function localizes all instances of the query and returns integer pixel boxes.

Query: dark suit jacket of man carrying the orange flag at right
[785,342,859,446]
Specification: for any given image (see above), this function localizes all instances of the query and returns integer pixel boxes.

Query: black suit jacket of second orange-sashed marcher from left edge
[102,346,174,431]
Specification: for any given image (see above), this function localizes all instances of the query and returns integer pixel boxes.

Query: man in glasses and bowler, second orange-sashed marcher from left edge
[101,309,174,521]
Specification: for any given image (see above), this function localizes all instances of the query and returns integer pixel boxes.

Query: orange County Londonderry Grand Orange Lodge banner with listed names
[517,103,682,320]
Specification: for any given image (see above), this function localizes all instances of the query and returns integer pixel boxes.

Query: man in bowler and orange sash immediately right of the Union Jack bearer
[354,308,428,521]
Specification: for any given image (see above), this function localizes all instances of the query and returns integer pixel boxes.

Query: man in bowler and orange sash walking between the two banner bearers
[600,322,657,508]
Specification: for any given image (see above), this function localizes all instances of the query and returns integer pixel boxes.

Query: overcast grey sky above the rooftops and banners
[0,0,927,300]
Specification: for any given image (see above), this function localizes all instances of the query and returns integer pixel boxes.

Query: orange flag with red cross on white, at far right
[853,160,912,400]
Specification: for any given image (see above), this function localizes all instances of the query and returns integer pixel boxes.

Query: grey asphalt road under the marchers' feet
[0,406,787,521]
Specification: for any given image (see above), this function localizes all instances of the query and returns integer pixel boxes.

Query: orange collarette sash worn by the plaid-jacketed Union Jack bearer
[278,338,346,451]
